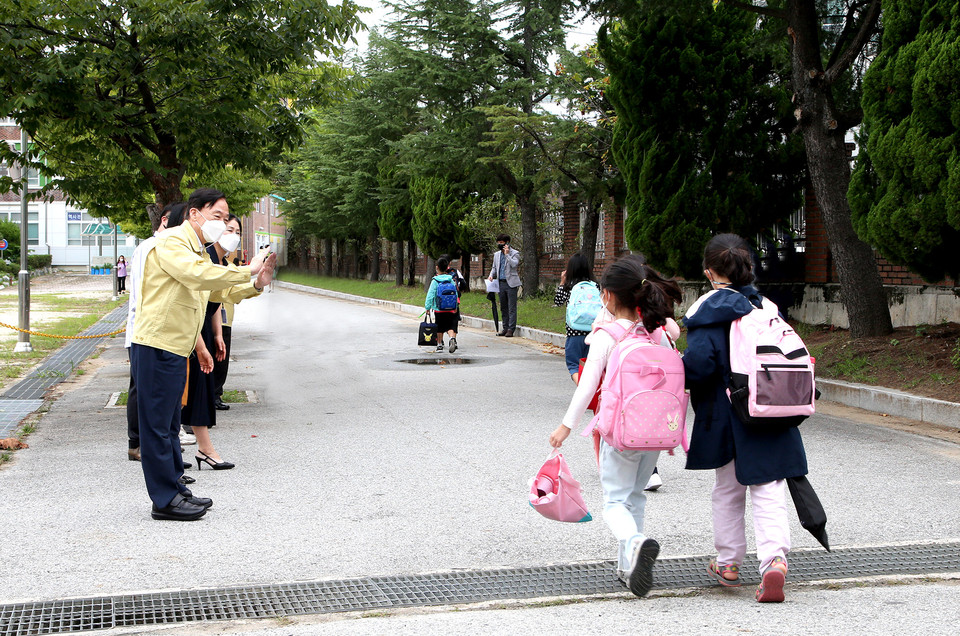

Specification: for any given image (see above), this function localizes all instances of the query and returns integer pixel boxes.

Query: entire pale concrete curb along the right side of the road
[276,281,960,430]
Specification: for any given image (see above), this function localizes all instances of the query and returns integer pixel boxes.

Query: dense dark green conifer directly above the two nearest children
[599,0,803,277]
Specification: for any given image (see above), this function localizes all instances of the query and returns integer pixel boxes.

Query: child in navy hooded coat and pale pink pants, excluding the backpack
[683,234,807,602]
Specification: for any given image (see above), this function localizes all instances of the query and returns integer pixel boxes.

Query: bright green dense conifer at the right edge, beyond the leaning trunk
[849,0,960,282]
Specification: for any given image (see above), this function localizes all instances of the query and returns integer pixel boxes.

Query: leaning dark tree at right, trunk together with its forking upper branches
[720,0,893,338]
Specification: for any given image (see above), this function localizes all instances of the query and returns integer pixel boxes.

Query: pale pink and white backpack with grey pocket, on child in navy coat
[727,290,816,426]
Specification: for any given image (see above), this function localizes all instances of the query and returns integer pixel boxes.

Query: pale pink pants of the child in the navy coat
[713,461,790,573]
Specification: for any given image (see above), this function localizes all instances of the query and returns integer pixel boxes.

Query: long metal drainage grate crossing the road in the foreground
[0,542,960,636]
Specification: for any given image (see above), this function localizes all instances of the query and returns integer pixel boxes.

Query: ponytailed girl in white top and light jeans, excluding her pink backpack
[550,255,685,596]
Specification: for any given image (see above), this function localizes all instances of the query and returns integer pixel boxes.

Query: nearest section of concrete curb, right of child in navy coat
[817,379,960,430]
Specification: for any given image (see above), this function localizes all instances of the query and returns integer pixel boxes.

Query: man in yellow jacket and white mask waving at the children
[130,188,276,521]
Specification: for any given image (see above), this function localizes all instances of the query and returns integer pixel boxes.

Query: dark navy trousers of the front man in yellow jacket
[130,344,187,508]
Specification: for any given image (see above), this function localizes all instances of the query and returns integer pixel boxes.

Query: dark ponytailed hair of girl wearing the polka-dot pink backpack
[600,254,683,331]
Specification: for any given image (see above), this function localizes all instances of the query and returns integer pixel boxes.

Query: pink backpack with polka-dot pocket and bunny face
[584,322,689,454]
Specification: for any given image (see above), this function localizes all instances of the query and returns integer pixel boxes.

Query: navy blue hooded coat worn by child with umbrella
[683,287,807,486]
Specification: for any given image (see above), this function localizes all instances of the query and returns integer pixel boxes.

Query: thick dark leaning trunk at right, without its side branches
[787,0,893,338]
